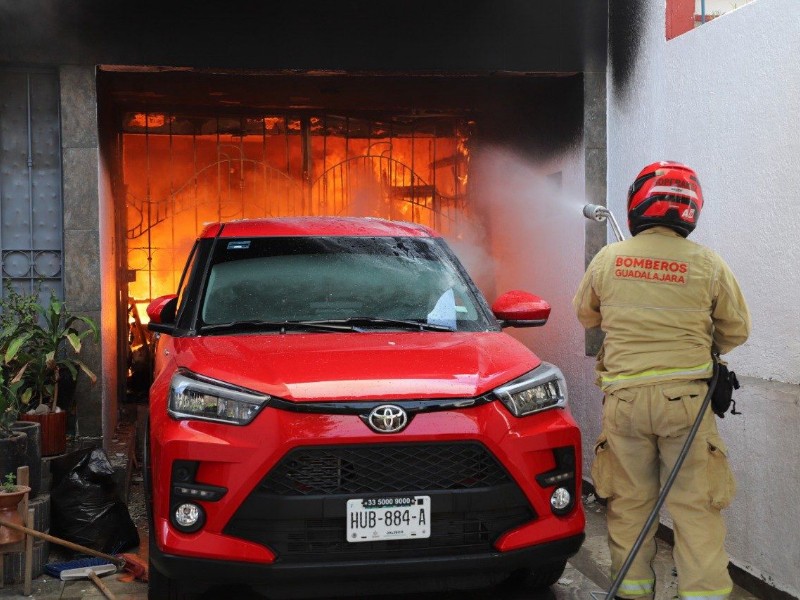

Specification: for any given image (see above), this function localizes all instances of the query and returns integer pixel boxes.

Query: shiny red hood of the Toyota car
[175,332,541,402]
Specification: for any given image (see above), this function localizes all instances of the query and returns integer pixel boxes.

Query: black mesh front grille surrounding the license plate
[225,442,536,563]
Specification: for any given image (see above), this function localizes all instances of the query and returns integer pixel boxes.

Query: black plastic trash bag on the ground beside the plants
[50,448,139,554]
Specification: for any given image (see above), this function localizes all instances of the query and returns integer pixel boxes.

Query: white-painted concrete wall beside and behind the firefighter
[608,0,800,596]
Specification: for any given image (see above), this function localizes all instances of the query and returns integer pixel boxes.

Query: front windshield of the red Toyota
[199,237,492,333]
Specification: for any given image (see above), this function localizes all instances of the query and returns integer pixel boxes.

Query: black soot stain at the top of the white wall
[608,0,647,96]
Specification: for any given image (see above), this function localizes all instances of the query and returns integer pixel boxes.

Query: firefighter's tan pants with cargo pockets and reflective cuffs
[592,381,735,600]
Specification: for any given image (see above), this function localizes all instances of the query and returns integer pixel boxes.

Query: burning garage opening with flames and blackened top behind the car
[98,68,582,391]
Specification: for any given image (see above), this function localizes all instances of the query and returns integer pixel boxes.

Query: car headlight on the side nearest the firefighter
[494,362,567,417]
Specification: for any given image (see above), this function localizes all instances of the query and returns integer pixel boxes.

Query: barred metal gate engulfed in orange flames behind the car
[119,113,471,317]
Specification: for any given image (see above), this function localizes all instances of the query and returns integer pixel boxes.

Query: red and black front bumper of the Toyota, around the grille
[151,394,585,581]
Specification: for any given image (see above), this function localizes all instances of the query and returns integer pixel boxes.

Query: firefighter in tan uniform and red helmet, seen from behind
[573,162,750,600]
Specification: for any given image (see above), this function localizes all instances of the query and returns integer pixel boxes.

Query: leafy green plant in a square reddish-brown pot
[13,293,99,456]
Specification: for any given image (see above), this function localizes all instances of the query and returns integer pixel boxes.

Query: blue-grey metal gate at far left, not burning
[0,69,63,301]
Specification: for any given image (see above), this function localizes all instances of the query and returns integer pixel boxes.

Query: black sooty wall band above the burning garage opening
[0,0,604,73]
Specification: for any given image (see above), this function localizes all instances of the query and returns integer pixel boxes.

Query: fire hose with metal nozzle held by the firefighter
[583,204,719,600]
